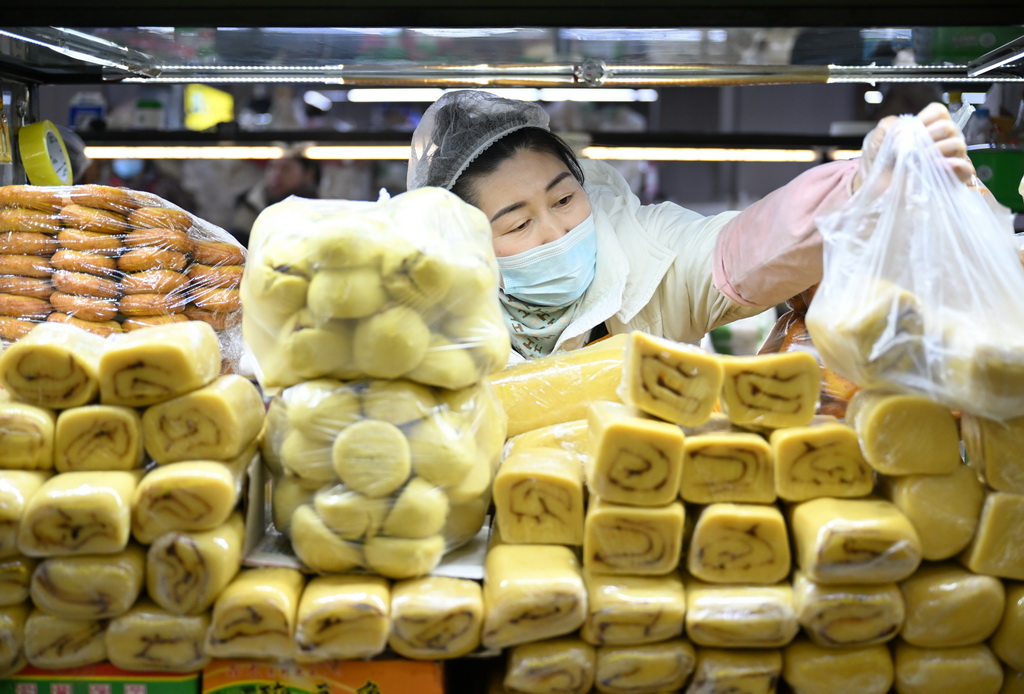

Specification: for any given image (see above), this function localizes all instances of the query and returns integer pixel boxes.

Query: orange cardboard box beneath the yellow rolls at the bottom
[200,660,444,694]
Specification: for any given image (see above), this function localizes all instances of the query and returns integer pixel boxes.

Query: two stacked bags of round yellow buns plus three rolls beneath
[226,188,510,663]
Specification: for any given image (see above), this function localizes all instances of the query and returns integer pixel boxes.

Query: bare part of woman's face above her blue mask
[474,150,590,257]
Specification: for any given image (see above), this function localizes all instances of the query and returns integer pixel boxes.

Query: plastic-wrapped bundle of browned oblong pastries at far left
[0,184,246,367]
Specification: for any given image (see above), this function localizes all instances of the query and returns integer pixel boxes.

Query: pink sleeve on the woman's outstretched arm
[712,161,857,306]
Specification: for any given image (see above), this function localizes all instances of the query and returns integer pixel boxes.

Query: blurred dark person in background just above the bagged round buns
[228,153,322,247]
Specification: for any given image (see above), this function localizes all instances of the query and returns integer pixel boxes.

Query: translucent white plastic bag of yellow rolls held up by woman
[806,117,1024,420]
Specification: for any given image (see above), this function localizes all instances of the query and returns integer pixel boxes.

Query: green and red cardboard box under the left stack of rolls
[0,663,201,694]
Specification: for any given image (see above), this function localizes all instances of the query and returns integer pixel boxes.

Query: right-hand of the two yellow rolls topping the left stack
[99,320,221,407]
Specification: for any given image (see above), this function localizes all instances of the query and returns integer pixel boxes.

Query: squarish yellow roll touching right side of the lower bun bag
[494,448,584,546]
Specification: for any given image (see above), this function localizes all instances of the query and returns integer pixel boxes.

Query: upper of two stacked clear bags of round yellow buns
[241,188,510,392]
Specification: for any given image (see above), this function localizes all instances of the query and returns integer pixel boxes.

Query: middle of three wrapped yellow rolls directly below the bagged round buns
[295,576,391,662]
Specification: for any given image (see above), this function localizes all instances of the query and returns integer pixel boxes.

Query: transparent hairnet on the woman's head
[407,89,548,190]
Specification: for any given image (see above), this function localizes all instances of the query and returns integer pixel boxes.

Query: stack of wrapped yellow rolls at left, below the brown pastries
[0,320,264,675]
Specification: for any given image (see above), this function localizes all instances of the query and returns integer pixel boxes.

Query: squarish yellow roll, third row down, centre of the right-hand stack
[686,504,791,583]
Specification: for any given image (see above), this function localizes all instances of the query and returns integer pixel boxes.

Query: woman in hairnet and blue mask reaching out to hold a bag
[409,90,974,358]
